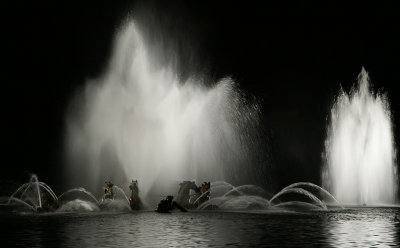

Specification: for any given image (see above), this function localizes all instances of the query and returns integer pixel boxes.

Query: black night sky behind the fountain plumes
[1,1,400,194]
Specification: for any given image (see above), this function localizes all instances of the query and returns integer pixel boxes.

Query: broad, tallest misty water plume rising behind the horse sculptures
[66,21,259,199]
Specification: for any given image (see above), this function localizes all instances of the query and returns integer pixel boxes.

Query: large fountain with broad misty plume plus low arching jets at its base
[0,21,346,214]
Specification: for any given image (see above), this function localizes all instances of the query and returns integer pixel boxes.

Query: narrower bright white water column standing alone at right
[322,68,397,205]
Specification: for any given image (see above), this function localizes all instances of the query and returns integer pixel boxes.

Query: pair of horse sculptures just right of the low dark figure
[176,181,211,209]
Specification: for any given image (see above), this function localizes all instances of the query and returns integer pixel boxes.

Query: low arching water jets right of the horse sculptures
[198,181,342,211]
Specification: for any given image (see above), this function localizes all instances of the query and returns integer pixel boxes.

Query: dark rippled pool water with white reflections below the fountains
[0,208,400,247]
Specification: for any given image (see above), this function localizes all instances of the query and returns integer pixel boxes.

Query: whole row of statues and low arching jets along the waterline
[0,175,342,213]
